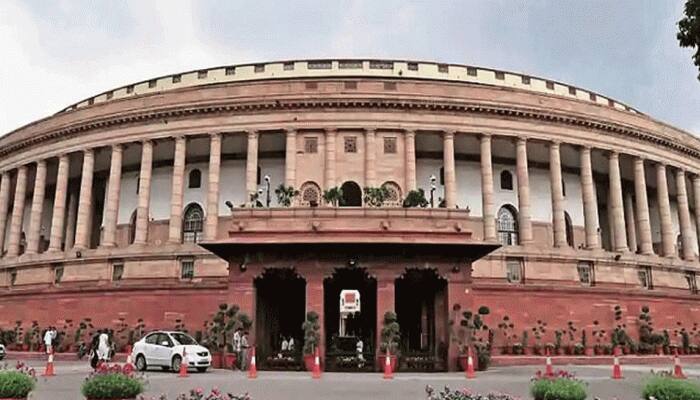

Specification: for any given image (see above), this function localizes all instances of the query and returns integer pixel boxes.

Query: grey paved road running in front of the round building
[12,362,700,400]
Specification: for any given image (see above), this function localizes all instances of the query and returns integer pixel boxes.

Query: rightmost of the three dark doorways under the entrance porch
[395,268,450,370]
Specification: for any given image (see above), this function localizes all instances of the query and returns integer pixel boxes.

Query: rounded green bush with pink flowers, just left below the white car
[80,364,144,400]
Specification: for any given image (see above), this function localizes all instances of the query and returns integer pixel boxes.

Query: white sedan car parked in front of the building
[131,331,211,372]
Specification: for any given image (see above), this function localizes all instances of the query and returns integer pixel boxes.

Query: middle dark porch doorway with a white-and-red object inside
[323,268,377,371]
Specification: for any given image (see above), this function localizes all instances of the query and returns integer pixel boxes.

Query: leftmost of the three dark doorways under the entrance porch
[255,268,306,369]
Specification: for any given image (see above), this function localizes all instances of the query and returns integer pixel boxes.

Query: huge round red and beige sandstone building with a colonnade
[0,60,700,368]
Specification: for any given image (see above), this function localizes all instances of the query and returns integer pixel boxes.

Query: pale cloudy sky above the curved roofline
[0,0,700,135]
